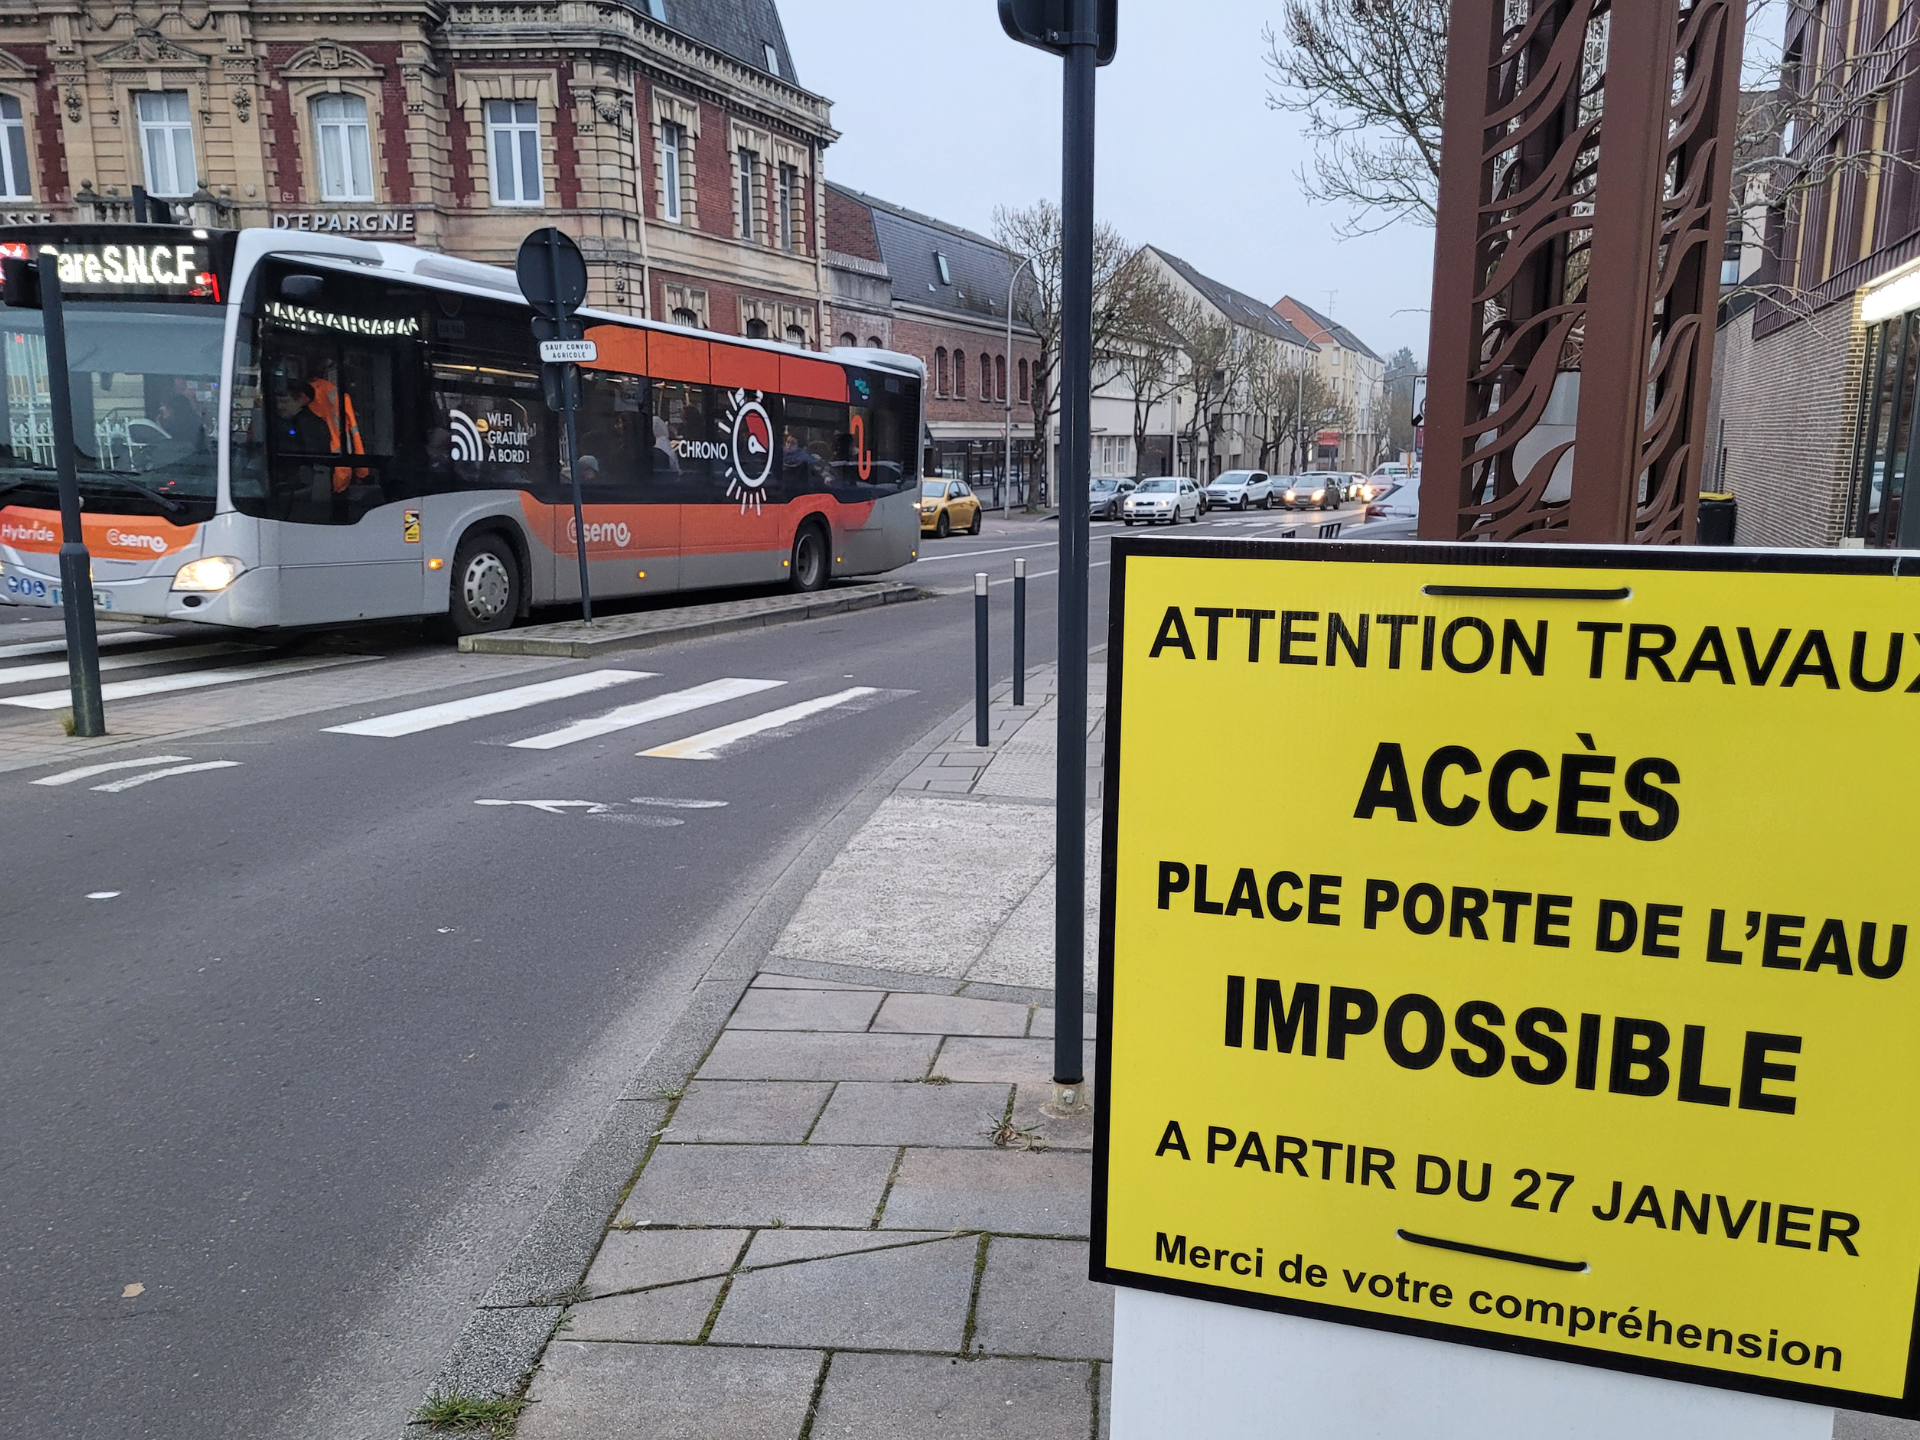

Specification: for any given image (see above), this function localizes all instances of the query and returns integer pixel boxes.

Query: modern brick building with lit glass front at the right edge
[1703,0,1920,547]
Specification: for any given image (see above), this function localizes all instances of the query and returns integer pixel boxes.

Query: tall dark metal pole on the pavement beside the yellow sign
[1054,0,1098,1110]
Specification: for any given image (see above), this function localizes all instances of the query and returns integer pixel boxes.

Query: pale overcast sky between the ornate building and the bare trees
[780,0,1432,359]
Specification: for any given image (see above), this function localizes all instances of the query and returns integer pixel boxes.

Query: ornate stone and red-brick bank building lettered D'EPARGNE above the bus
[0,0,837,346]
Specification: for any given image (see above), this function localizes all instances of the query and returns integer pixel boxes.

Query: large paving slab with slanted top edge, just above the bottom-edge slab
[712,1236,979,1352]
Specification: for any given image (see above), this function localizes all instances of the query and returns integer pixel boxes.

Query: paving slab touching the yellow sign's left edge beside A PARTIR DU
[879,1150,1092,1235]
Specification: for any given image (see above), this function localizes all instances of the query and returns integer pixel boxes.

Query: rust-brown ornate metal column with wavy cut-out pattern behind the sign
[1421,0,1741,543]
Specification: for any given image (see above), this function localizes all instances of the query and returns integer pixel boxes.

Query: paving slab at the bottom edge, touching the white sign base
[814,1354,1092,1440]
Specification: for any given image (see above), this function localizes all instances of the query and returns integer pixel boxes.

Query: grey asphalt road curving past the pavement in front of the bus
[0,513,1382,1440]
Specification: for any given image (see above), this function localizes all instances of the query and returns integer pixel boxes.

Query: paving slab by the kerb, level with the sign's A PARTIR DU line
[620,1144,894,1229]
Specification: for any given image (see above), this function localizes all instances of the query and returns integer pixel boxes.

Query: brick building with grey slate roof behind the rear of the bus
[826,182,1039,503]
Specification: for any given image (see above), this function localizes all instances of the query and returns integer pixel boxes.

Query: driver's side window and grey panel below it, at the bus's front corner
[234,267,424,626]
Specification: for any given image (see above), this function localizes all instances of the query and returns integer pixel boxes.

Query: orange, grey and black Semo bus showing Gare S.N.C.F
[0,225,925,634]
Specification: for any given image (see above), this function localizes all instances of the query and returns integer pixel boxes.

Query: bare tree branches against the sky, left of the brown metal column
[1263,0,1448,234]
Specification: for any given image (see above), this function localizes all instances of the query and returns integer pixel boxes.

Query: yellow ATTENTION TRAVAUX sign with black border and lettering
[1094,540,1920,1415]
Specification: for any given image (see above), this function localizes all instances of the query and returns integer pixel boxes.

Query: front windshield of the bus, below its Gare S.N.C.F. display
[0,301,225,524]
